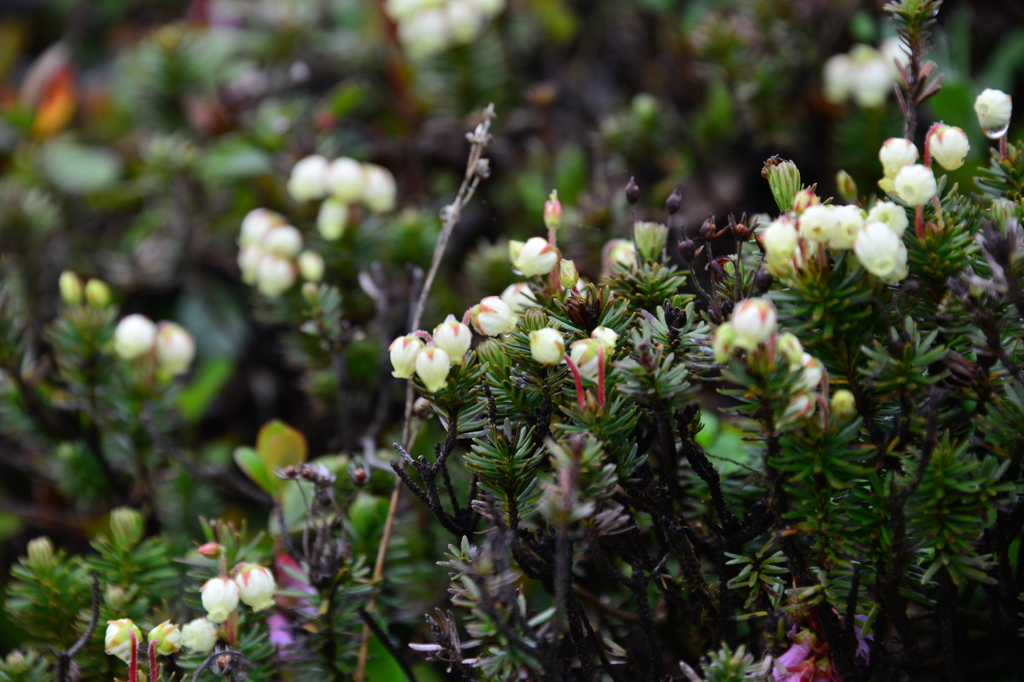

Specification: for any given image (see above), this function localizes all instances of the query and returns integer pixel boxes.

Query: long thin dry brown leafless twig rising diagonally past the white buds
[354,103,496,682]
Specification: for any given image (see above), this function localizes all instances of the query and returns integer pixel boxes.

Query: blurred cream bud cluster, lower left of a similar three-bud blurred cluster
[239,208,324,296]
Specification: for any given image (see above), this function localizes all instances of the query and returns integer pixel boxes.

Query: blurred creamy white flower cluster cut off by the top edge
[384,0,505,59]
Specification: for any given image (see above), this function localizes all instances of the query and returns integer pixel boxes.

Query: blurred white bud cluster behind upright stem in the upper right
[822,38,909,108]
